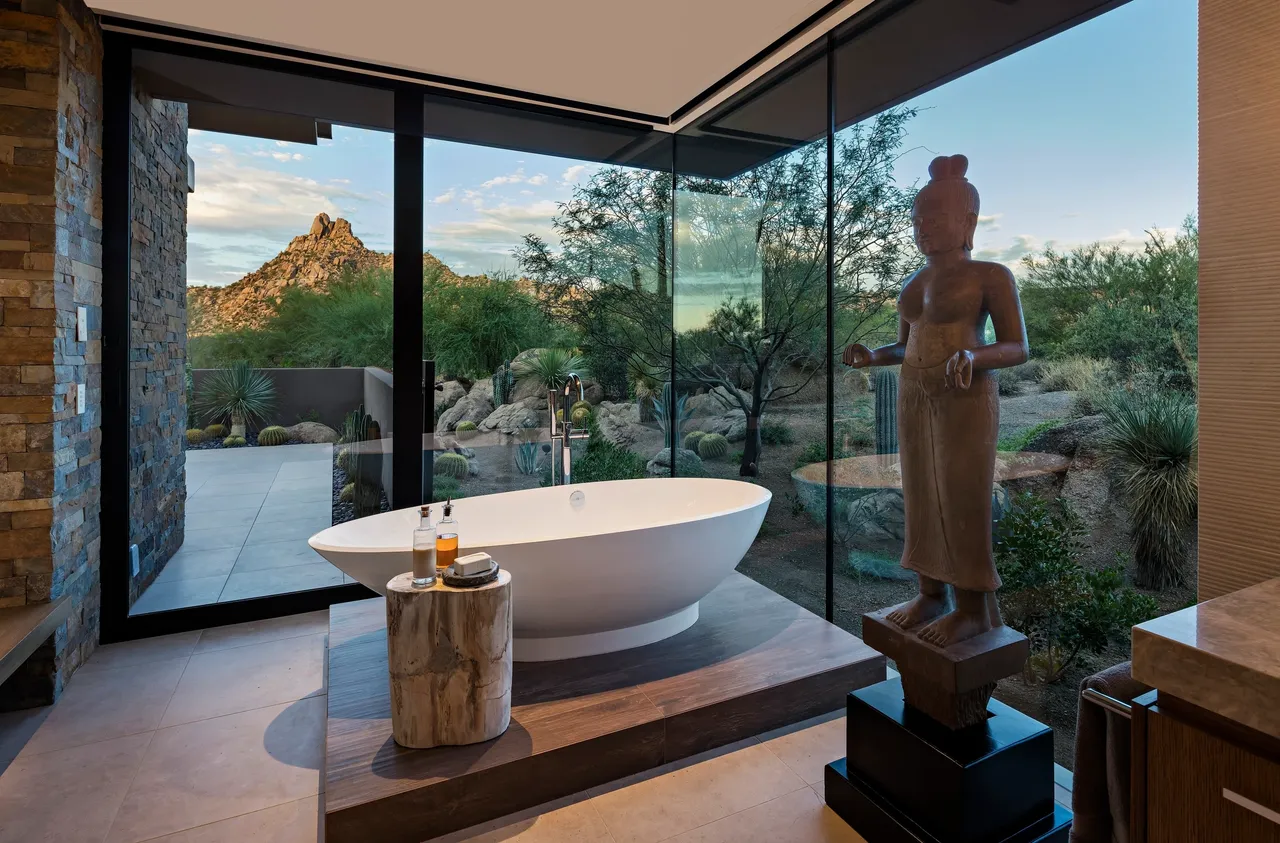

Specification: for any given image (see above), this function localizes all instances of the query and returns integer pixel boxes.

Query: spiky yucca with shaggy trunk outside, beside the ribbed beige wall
[1102,393,1198,588]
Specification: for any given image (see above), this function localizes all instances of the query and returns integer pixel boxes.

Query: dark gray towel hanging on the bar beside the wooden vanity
[1071,661,1151,843]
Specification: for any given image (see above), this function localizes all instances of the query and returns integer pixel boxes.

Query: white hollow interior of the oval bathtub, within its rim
[312,477,772,551]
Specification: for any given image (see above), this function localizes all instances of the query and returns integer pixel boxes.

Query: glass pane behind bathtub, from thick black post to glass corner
[422,129,682,500]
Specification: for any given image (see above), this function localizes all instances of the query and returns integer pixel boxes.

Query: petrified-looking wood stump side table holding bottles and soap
[387,571,511,750]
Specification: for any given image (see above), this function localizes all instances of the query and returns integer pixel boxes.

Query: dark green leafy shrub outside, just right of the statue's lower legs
[995,492,1158,682]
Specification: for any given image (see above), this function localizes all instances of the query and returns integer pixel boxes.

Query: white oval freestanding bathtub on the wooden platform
[310,477,773,661]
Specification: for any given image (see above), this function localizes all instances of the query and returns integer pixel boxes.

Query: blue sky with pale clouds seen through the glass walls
[187,0,1197,284]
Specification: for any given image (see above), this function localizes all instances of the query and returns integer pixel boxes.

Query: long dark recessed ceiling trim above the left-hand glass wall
[99,14,669,128]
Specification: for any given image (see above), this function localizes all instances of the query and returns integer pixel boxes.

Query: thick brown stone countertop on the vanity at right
[1133,578,1280,738]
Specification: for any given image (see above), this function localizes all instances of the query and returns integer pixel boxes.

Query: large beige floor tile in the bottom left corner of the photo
[0,733,152,843]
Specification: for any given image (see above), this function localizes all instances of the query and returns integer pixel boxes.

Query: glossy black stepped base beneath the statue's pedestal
[826,679,1070,843]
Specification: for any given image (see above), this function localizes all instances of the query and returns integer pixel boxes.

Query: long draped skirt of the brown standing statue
[897,363,1000,591]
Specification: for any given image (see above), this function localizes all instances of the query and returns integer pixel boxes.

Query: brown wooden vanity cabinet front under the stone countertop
[1130,695,1280,843]
